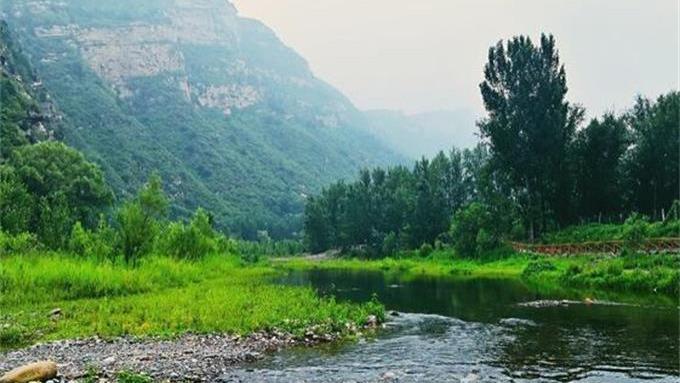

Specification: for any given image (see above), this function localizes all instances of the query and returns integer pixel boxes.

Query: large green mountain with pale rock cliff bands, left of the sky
[2,0,403,237]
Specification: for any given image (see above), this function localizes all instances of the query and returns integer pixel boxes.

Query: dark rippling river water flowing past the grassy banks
[224,270,680,382]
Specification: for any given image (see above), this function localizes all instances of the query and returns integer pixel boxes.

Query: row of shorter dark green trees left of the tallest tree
[305,146,494,255]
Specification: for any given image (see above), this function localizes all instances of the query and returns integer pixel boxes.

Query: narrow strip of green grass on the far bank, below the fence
[280,250,680,302]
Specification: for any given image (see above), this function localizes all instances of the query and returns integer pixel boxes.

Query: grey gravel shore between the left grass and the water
[0,331,337,382]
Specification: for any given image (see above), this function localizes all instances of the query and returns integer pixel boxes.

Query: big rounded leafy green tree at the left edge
[0,142,112,248]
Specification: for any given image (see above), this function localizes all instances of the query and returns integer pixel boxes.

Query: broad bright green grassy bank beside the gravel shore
[0,253,383,349]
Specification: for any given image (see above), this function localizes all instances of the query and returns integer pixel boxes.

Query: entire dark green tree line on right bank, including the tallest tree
[304,35,680,255]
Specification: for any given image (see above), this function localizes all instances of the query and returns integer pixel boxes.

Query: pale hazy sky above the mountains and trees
[234,0,680,115]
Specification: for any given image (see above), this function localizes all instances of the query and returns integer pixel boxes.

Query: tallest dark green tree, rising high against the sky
[479,35,583,239]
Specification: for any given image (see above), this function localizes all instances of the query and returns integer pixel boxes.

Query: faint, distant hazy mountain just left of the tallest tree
[365,110,479,159]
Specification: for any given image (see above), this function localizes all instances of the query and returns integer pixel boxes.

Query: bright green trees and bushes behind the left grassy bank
[0,141,302,265]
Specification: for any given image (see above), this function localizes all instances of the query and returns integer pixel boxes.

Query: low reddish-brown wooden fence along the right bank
[509,238,680,255]
